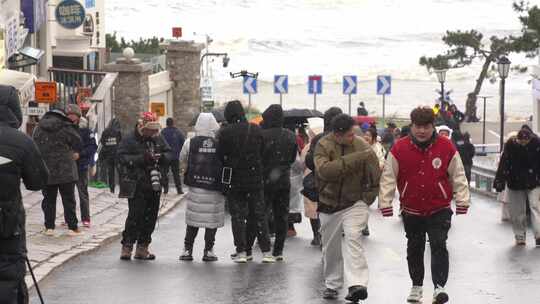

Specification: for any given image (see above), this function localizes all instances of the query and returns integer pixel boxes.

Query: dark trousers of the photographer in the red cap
[122,185,160,245]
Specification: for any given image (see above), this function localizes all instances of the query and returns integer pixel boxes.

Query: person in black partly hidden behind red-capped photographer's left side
[98,118,122,193]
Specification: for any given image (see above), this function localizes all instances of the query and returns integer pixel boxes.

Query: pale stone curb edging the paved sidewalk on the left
[25,196,183,289]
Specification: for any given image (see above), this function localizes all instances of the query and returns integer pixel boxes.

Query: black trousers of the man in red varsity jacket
[403,209,453,287]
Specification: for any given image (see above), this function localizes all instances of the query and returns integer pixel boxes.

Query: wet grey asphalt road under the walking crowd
[31,195,540,304]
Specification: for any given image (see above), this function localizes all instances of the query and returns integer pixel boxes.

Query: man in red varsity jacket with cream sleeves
[379,107,470,304]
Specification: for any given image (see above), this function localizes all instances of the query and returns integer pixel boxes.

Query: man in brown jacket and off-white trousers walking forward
[314,114,380,303]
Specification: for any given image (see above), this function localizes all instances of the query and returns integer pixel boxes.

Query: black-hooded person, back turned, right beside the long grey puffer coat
[217,100,275,263]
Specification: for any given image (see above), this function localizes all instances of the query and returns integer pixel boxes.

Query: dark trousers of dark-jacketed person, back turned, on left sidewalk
[41,183,78,230]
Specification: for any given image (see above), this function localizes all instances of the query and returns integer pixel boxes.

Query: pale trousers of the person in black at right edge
[507,187,540,239]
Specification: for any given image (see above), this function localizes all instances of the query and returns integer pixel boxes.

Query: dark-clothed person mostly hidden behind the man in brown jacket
[304,107,343,246]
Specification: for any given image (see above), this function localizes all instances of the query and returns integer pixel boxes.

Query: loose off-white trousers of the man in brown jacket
[319,201,369,290]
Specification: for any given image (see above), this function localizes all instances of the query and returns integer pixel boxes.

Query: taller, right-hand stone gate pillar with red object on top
[167,41,204,131]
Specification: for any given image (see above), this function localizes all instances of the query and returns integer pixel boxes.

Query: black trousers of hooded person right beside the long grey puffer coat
[227,190,270,252]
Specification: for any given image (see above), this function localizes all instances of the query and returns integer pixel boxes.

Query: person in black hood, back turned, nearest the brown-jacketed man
[248,105,298,260]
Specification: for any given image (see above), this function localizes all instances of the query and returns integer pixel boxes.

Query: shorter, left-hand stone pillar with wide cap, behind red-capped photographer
[105,59,152,134]
